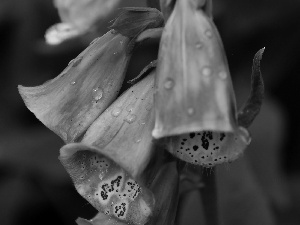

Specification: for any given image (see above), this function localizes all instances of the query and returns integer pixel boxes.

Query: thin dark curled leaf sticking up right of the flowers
[238,48,265,128]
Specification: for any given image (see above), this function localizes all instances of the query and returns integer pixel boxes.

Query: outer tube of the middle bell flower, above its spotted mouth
[82,72,154,177]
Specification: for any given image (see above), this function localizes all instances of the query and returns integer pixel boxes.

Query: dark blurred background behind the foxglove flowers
[0,0,300,225]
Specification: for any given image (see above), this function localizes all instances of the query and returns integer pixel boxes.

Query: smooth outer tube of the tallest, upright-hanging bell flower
[152,0,236,138]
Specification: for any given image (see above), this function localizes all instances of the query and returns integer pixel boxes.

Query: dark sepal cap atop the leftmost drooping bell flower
[110,7,164,38]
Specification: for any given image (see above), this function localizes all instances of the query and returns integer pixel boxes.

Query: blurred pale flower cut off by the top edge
[45,0,120,44]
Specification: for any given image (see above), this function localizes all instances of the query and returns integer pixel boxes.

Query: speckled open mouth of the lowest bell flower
[59,143,154,224]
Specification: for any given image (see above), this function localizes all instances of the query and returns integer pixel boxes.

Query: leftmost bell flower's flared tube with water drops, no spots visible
[19,30,131,142]
